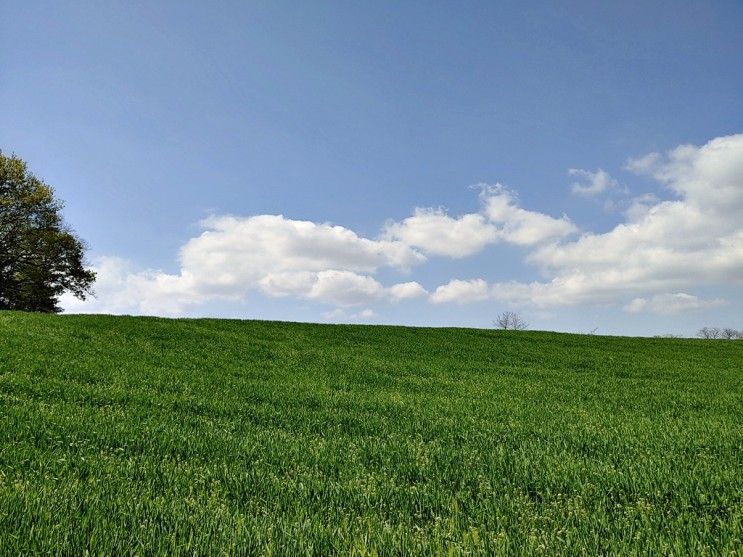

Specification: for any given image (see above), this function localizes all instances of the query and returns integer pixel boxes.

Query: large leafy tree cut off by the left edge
[0,152,95,312]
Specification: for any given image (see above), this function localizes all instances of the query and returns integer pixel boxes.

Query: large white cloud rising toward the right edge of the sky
[432,135,743,308]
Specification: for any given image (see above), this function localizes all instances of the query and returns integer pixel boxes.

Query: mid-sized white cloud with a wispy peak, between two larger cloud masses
[383,184,578,258]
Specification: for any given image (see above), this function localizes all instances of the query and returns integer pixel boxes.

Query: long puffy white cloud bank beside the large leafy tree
[67,215,427,315]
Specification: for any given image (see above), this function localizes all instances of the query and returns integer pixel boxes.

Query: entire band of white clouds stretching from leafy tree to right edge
[62,134,743,317]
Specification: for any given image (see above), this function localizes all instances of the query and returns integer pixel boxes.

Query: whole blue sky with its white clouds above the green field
[0,0,743,335]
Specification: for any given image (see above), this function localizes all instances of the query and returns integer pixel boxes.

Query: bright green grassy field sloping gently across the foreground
[0,312,743,555]
